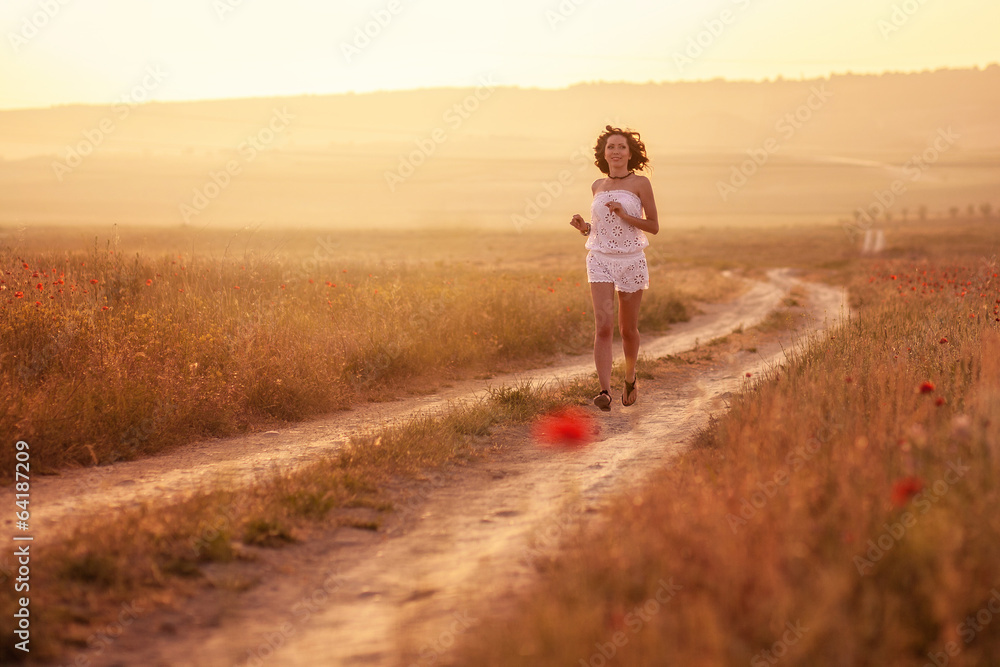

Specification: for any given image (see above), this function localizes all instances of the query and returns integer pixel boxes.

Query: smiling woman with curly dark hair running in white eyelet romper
[570,125,660,411]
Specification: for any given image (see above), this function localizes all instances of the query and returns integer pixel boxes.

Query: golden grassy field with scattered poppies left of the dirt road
[0,230,739,481]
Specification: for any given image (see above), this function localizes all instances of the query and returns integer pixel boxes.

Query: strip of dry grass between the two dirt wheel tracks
[0,381,589,661]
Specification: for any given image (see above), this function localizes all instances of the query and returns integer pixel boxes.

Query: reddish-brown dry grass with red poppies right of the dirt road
[458,247,1000,667]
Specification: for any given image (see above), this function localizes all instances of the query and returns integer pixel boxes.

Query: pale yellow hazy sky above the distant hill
[0,0,1000,108]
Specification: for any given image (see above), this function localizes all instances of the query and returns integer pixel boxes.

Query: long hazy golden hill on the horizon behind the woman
[0,65,1000,228]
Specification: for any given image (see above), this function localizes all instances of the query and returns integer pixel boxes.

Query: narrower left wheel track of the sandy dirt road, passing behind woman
[19,270,804,540]
